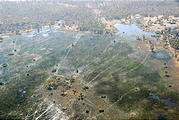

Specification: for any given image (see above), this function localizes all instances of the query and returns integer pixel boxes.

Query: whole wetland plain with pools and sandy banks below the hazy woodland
[0,2,179,120]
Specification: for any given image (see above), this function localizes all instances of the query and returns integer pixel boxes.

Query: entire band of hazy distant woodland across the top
[0,0,179,33]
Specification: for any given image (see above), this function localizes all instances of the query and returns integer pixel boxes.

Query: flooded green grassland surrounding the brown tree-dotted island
[0,24,179,119]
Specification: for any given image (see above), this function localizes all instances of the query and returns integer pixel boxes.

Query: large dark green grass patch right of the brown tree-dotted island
[91,56,179,119]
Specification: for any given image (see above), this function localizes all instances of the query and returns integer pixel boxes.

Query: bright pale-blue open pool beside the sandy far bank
[114,23,154,39]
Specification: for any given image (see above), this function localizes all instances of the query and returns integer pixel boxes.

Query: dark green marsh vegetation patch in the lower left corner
[0,71,47,119]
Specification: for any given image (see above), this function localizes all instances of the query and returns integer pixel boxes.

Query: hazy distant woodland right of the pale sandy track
[101,1,179,19]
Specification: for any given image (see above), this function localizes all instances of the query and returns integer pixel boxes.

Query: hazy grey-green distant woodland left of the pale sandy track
[0,1,104,33]
